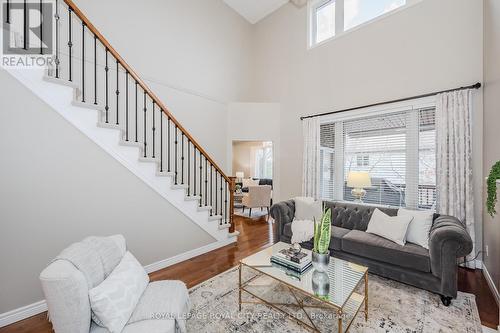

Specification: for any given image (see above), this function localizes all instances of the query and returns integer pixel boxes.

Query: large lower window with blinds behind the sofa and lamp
[320,107,436,209]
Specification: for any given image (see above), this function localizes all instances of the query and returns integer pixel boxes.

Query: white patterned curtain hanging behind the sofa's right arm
[436,90,476,268]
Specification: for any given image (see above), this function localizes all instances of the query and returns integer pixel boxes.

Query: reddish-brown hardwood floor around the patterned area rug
[0,216,498,333]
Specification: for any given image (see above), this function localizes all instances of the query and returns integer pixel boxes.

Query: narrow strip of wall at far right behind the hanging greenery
[484,0,500,306]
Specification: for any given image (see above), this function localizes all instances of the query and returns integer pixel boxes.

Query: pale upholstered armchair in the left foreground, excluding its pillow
[40,235,190,333]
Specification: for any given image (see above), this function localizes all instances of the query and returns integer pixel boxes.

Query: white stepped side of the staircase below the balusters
[8,69,228,241]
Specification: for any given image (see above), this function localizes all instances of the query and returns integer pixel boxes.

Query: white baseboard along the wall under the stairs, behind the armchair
[0,237,237,327]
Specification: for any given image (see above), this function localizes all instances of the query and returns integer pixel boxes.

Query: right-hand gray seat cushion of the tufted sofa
[341,230,431,272]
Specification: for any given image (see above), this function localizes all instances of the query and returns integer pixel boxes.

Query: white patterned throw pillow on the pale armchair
[89,252,149,333]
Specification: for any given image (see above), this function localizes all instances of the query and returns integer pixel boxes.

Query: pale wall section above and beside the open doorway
[227,103,283,202]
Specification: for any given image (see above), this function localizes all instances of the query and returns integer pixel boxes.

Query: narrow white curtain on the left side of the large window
[302,117,320,199]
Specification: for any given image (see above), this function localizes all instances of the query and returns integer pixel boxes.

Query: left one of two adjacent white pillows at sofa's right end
[366,208,413,246]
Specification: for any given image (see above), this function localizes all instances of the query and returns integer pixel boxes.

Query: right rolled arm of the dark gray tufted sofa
[429,215,473,297]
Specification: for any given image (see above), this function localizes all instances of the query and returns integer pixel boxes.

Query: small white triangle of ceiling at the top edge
[224,0,288,24]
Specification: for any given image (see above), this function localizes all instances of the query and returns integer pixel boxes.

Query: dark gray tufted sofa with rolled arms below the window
[271,200,472,306]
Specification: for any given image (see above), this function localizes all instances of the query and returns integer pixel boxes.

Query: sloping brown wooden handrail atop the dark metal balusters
[64,0,232,184]
